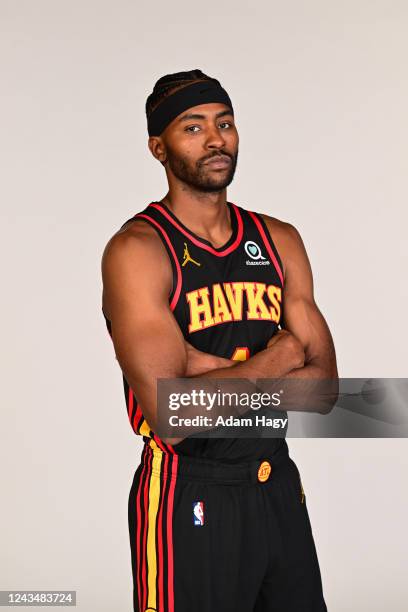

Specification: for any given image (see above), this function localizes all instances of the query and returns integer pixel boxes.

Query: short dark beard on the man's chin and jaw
[167,149,238,193]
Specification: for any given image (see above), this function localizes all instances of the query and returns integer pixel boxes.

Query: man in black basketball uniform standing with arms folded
[102,70,337,612]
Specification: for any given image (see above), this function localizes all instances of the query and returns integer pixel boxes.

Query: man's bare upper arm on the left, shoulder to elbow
[102,228,187,423]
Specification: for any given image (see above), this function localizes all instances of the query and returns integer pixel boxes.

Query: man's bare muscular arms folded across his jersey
[102,221,337,444]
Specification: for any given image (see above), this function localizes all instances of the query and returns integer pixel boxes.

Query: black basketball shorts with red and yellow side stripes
[129,443,327,612]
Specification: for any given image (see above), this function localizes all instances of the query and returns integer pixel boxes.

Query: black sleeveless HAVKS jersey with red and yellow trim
[103,202,286,462]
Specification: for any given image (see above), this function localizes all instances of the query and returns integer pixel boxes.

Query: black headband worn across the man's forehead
[147,81,234,136]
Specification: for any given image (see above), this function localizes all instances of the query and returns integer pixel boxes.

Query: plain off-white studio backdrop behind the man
[0,0,408,612]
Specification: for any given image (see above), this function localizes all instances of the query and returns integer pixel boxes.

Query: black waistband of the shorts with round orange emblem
[141,444,292,484]
